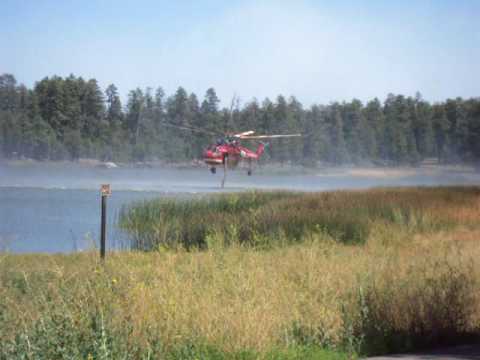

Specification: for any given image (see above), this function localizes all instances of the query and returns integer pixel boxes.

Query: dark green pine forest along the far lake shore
[0,74,480,166]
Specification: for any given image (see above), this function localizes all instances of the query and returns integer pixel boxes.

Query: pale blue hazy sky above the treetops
[0,0,480,106]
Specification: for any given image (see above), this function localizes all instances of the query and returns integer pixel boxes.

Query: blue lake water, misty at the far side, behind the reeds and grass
[0,164,480,253]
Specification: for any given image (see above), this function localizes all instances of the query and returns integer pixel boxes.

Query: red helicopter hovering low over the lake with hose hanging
[158,122,302,188]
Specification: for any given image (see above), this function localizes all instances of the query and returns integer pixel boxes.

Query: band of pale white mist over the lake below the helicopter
[0,163,480,193]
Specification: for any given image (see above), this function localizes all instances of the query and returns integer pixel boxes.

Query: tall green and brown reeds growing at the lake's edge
[119,188,480,250]
